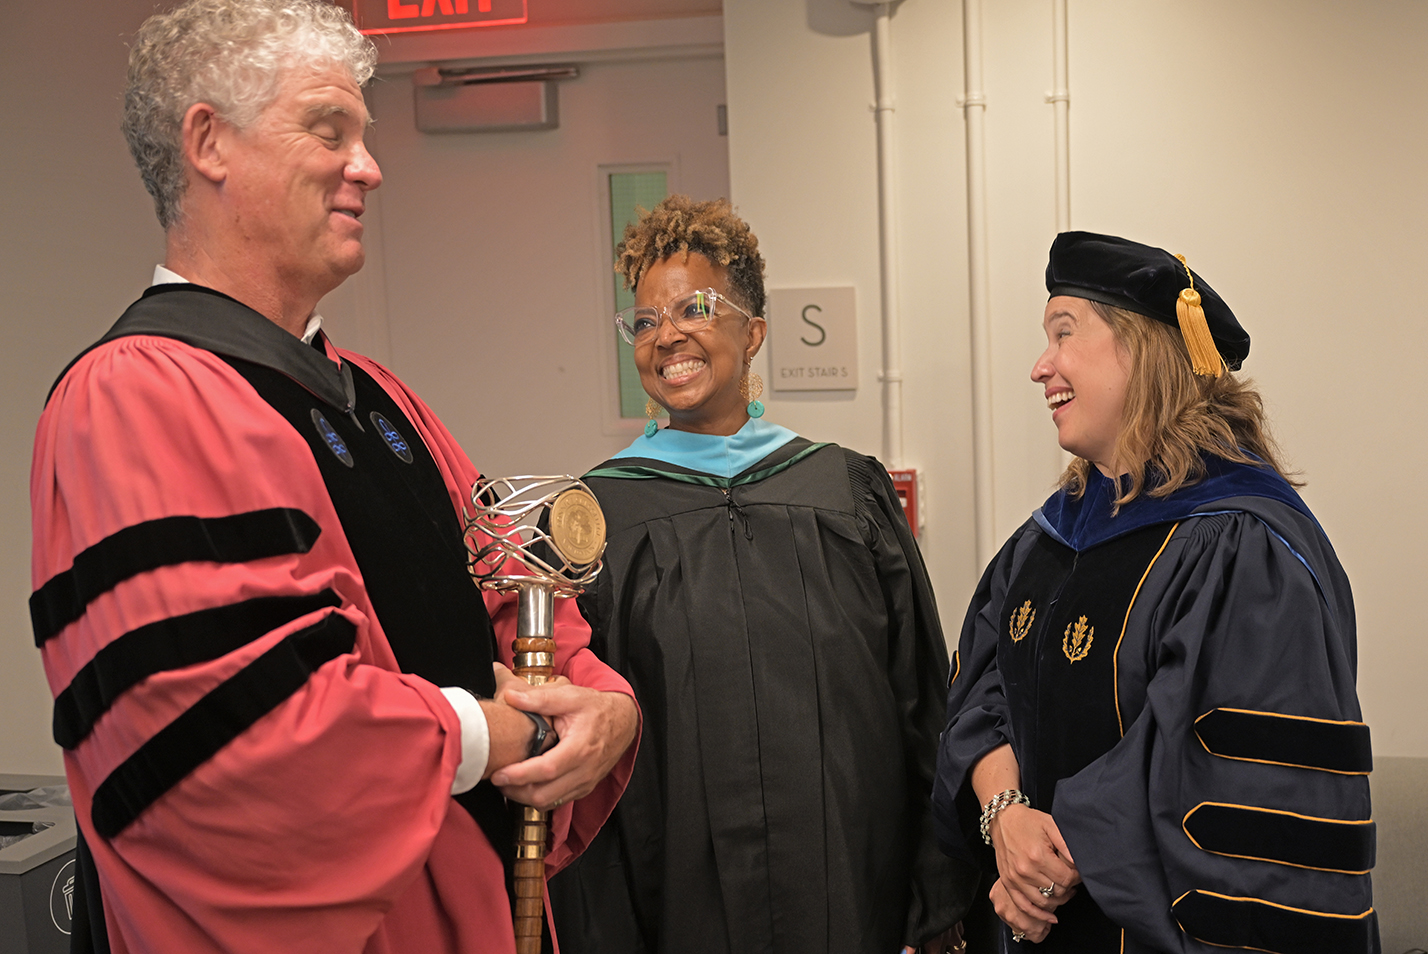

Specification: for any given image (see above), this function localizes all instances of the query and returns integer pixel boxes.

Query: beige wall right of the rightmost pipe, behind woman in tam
[1071,0,1428,755]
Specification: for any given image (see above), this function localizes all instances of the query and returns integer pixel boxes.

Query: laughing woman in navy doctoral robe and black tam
[934,233,1378,954]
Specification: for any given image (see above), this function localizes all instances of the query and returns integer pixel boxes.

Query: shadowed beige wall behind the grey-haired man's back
[0,0,163,773]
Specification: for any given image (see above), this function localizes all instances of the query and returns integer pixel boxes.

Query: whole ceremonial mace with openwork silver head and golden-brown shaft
[466,477,605,954]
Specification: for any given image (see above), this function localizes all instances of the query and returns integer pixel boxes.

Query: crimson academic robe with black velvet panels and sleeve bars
[31,286,634,954]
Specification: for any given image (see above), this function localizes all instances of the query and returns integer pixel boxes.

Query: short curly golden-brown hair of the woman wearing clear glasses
[615,196,764,317]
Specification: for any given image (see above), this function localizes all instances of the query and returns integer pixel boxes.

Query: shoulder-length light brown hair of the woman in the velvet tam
[1061,301,1304,510]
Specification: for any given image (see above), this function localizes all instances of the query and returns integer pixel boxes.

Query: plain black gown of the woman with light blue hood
[551,438,975,954]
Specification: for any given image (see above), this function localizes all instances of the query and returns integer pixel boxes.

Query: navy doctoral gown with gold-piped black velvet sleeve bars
[934,458,1378,954]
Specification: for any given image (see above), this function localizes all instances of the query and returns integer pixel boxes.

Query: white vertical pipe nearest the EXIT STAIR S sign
[873,3,902,468]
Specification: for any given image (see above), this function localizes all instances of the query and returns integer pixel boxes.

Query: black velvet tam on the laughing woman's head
[1047,231,1250,371]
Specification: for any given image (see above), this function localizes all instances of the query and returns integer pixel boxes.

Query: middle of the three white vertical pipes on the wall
[961,0,997,566]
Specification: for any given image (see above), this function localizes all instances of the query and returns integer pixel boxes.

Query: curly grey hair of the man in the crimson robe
[123,0,377,229]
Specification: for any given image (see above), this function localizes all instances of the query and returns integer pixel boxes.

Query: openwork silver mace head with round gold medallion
[466,476,605,597]
